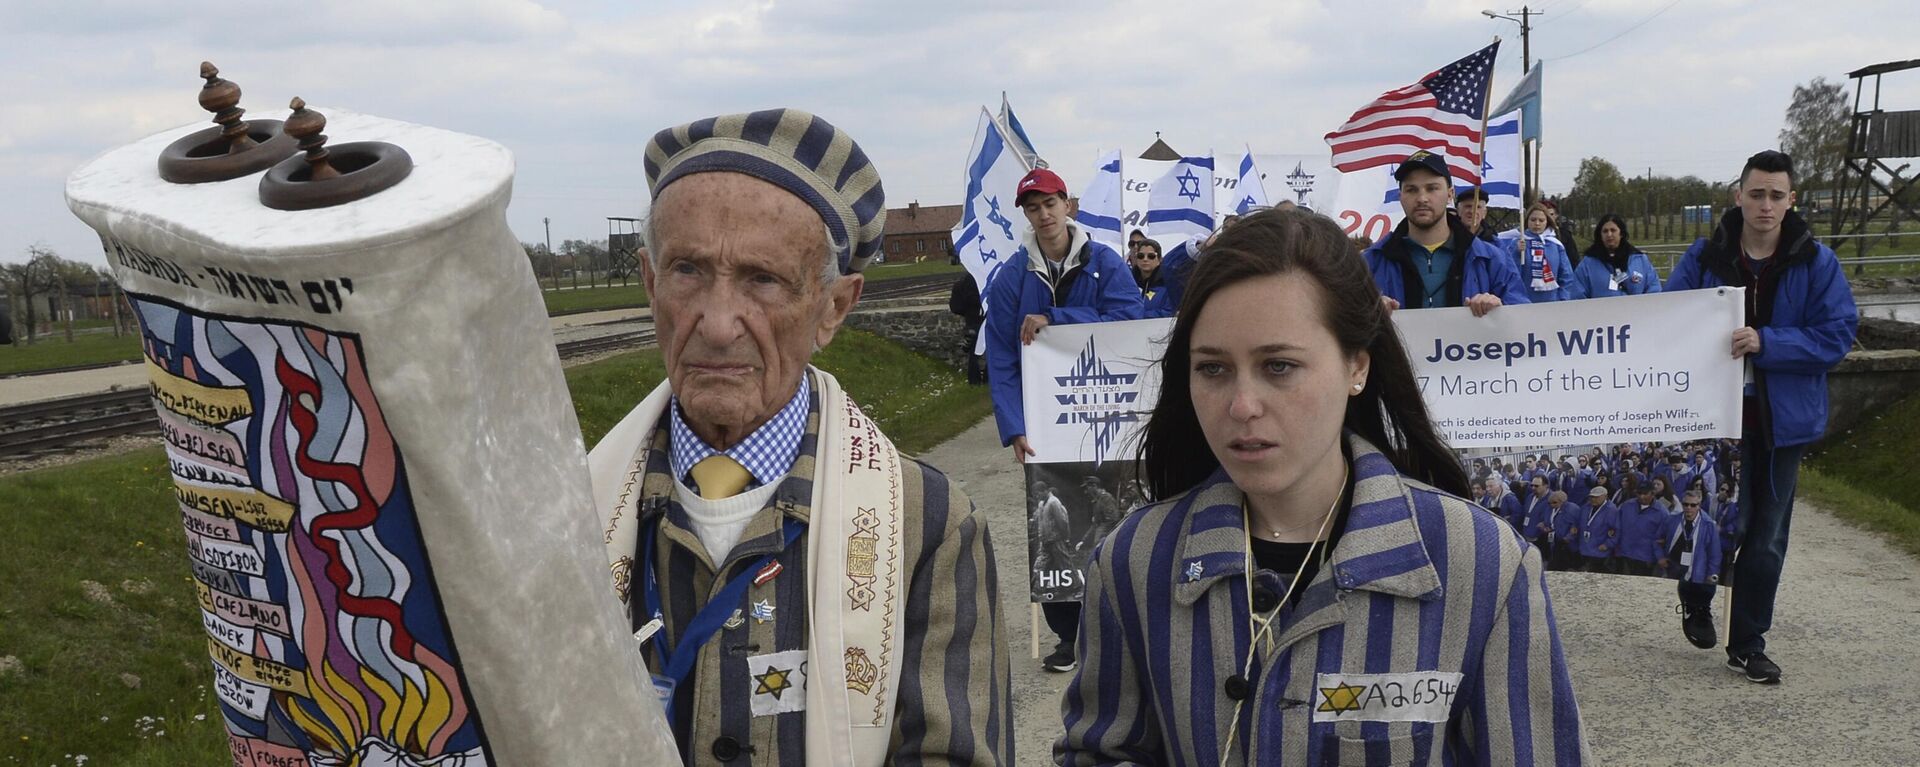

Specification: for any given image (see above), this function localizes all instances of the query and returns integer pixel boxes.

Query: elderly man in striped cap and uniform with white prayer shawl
[589,110,1014,765]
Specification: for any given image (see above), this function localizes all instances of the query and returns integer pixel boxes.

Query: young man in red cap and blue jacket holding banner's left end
[985,167,1146,671]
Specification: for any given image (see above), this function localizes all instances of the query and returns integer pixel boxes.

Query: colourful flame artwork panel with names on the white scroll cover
[132,296,492,767]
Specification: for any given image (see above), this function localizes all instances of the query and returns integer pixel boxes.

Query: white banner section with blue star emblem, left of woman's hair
[1020,317,1173,463]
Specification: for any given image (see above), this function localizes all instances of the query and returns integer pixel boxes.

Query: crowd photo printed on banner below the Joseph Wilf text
[1459,438,1745,584]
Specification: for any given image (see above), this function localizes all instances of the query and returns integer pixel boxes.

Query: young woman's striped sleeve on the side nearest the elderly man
[1054,538,1162,767]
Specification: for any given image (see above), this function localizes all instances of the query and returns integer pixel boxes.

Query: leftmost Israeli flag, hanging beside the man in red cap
[952,108,1029,292]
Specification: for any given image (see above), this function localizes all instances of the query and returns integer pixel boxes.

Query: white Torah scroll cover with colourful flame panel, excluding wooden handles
[67,110,678,767]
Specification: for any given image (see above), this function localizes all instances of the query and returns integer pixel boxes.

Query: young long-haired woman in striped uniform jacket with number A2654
[1054,211,1590,765]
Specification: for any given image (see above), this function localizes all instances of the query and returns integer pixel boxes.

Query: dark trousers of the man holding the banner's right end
[1680,438,1807,656]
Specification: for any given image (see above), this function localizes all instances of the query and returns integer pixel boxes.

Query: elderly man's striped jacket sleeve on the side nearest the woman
[887,465,1014,767]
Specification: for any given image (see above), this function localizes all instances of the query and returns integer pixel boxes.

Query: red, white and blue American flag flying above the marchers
[1327,40,1500,185]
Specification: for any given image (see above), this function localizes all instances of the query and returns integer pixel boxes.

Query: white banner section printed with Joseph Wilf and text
[1390,288,1743,450]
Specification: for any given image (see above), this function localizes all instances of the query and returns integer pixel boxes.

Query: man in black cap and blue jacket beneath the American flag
[1361,150,1528,317]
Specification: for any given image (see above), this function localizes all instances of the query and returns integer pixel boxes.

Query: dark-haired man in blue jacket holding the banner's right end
[1667,150,1860,684]
